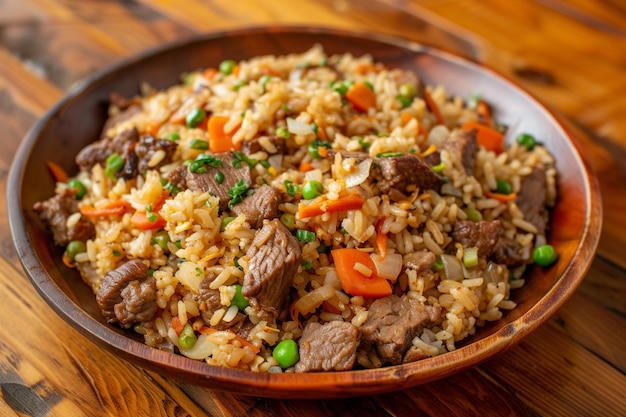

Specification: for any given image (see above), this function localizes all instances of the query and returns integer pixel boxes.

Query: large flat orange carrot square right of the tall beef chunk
[331,248,392,298]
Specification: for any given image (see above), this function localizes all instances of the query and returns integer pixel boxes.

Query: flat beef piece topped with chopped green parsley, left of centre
[168,152,252,210]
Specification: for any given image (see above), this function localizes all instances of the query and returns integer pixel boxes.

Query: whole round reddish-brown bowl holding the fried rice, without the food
[8,28,601,398]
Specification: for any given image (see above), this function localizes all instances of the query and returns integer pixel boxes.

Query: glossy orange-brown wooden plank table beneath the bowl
[0,0,626,416]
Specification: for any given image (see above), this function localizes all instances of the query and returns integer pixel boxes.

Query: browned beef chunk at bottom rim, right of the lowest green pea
[294,321,359,372]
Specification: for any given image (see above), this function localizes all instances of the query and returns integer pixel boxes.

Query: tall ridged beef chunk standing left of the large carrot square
[241,219,302,322]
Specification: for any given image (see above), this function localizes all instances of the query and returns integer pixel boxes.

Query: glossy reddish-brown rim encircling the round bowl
[7,26,602,398]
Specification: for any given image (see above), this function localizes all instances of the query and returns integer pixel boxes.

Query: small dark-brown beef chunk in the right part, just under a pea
[452,220,502,258]
